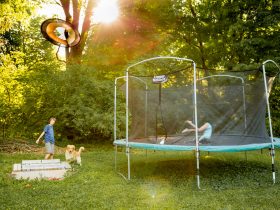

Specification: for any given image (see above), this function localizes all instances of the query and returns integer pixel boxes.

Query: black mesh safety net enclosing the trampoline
[115,56,273,146]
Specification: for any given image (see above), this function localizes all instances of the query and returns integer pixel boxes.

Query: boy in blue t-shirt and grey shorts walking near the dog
[36,117,56,160]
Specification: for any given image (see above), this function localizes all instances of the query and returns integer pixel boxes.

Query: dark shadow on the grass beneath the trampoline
[116,150,272,190]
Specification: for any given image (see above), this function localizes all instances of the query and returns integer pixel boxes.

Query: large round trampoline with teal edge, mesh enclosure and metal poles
[114,57,280,188]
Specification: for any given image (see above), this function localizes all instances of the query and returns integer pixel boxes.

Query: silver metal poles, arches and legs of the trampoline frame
[114,56,280,189]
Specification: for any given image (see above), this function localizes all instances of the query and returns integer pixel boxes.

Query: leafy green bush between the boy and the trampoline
[51,65,117,141]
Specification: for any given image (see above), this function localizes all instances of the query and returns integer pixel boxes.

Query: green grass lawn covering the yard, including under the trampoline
[0,142,280,210]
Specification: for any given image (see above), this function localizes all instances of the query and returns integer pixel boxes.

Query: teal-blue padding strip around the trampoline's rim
[114,138,280,152]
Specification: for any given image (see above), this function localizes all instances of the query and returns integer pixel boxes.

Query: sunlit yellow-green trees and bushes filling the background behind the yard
[0,0,280,142]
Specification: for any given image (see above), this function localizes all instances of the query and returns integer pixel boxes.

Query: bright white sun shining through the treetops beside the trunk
[92,0,119,23]
